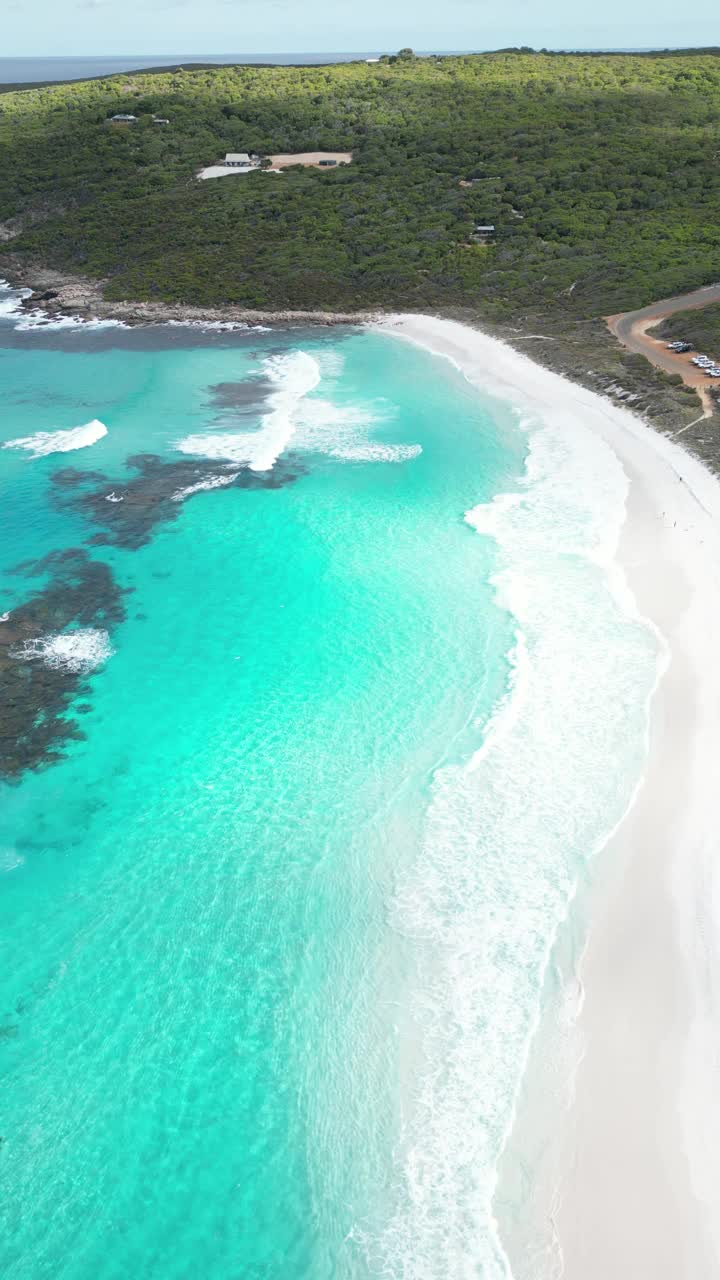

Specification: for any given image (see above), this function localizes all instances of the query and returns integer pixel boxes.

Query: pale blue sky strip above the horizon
[0,0,720,58]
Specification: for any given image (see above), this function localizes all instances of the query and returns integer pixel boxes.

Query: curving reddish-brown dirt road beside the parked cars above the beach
[607,284,720,417]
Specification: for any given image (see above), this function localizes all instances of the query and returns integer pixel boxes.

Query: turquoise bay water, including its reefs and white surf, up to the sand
[0,292,657,1280]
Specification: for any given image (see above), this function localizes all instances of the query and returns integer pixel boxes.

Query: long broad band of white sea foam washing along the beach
[365,409,664,1280]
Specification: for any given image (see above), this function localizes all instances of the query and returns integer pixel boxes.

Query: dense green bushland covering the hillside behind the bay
[0,51,720,321]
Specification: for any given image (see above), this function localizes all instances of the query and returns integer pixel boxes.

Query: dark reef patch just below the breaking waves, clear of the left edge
[53,453,300,550]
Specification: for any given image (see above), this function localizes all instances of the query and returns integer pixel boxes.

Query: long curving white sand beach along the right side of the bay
[382,316,720,1280]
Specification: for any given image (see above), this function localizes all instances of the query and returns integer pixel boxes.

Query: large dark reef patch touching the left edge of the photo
[0,547,126,781]
